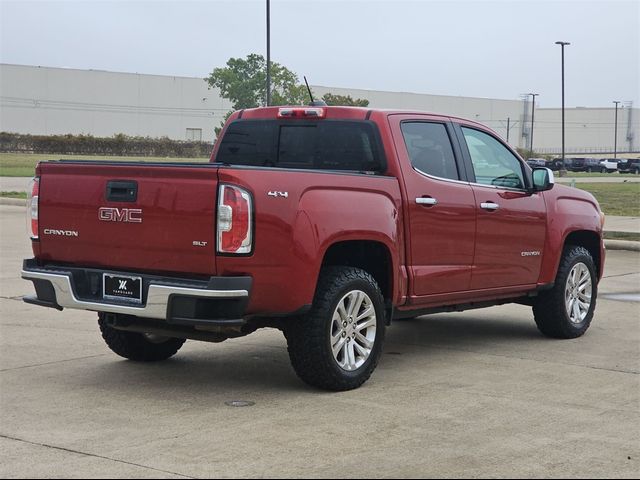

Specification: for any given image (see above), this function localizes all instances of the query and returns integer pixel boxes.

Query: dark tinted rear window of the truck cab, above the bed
[216,120,386,173]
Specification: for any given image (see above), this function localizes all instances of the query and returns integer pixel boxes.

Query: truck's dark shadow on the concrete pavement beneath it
[79,314,548,401]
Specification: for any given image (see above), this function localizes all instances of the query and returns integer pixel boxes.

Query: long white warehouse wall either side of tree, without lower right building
[0,64,522,146]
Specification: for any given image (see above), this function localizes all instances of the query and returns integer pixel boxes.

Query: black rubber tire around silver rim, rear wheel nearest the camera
[284,267,386,391]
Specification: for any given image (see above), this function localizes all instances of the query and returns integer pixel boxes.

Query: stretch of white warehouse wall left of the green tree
[0,64,231,141]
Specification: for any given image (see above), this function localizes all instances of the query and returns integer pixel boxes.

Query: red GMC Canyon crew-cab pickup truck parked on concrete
[22,106,605,390]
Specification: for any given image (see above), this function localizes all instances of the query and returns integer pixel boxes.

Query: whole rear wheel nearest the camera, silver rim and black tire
[285,267,386,391]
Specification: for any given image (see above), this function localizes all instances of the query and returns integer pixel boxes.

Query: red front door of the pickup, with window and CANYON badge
[456,125,546,290]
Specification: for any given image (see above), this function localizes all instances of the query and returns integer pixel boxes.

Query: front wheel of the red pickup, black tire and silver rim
[533,245,598,338]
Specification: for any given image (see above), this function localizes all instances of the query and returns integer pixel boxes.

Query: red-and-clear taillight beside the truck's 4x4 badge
[217,185,253,253]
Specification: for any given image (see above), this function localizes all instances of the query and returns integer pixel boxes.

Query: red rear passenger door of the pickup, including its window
[389,115,476,303]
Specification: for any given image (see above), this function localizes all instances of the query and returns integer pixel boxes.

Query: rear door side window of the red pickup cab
[401,122,460,180]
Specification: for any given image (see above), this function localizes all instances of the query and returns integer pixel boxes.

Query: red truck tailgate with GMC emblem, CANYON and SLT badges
[34,161,218,275]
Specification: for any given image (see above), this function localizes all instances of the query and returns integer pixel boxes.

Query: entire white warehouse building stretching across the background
[0,64,640,154]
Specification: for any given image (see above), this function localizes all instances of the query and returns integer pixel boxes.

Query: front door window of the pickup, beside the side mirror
[462,127,525,189]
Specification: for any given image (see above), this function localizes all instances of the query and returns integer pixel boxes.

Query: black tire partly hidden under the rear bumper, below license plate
[98,313,186,362]
